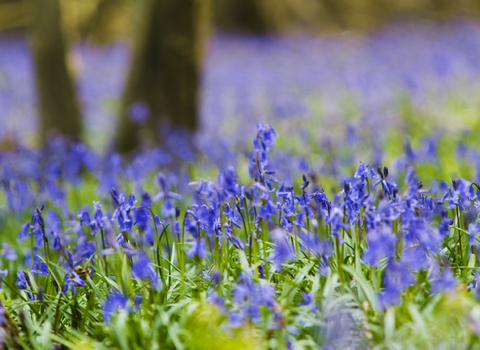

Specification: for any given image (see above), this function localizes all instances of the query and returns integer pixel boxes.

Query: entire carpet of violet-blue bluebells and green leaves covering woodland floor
[0,22,480,350]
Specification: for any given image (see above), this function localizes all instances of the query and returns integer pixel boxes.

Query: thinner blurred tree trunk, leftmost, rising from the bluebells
[31,0,82,142]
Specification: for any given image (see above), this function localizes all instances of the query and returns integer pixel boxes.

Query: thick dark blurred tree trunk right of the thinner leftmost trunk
[117,0,209,152]
